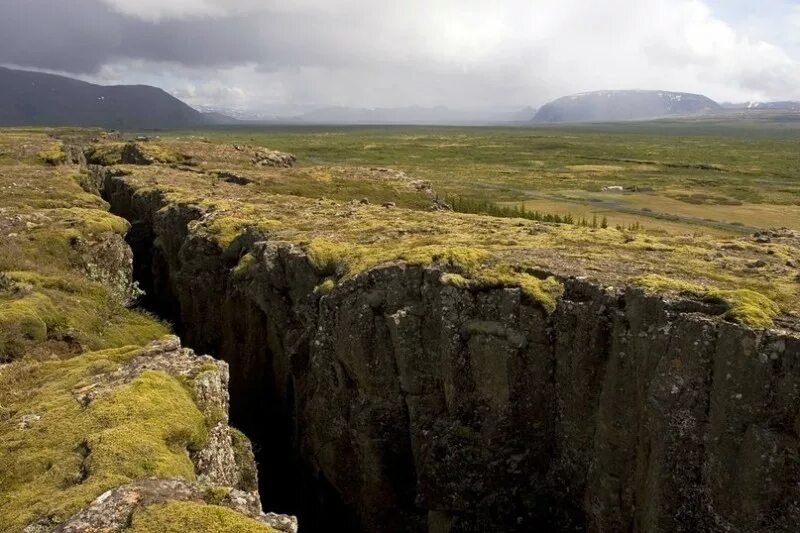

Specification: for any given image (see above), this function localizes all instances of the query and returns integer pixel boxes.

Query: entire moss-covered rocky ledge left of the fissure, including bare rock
[0,130,297,533]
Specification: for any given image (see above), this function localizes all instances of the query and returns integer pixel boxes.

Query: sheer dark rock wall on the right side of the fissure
[99,168,800,533]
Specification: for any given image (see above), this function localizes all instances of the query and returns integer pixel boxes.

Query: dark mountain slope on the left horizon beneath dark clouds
[0,67,230,129]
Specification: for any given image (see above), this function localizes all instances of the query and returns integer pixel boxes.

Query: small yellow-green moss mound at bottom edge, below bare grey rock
[126,502,275,533]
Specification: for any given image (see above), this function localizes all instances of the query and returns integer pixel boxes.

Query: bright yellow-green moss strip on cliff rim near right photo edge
[633,274,780,328]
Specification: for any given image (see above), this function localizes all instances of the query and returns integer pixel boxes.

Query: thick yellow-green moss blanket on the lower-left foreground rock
[0,347,206,531]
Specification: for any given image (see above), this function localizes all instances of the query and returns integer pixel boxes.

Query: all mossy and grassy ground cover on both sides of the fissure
[0,119,800,531]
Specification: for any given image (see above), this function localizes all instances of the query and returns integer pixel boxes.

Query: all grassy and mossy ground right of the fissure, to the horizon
[109,123,800,326]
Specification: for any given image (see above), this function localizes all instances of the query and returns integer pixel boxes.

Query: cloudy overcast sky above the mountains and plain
[0,0,800,109]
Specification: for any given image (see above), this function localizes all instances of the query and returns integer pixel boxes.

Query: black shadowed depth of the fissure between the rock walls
[120,204,341,532]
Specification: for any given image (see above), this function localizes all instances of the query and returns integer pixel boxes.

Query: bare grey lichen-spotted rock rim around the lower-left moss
[19,337,297,533]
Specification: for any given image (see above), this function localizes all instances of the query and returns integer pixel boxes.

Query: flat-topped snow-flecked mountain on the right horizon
[533,91,722,123]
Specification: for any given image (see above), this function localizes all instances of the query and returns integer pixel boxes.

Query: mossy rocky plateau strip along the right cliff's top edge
[97,133,800,325]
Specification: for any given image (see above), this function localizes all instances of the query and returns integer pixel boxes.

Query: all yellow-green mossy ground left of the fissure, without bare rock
[0,130,206,531]
